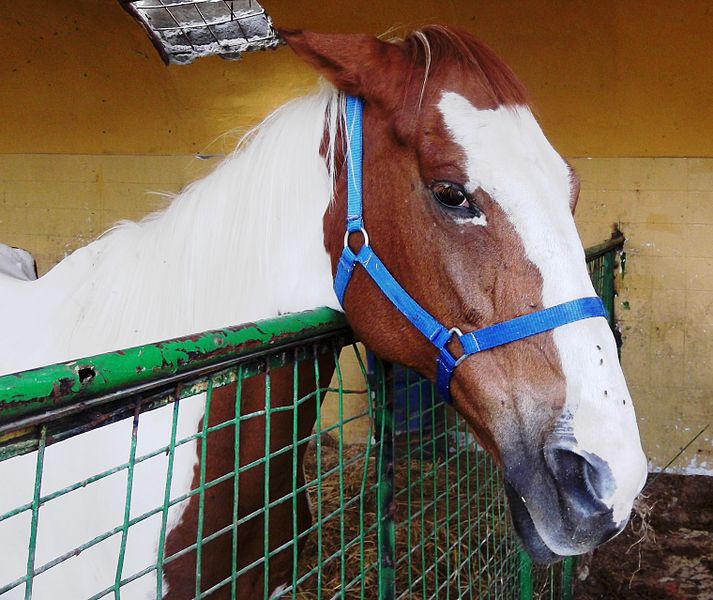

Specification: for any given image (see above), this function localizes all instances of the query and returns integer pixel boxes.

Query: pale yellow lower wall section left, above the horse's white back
[0,154,217,274]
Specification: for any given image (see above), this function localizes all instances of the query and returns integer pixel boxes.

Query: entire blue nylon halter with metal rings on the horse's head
[334,96,607,404]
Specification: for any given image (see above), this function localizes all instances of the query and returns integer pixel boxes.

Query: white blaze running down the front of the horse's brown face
[438,92,646,523]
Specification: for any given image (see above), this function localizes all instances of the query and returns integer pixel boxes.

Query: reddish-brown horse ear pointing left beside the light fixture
[279,29,406,105]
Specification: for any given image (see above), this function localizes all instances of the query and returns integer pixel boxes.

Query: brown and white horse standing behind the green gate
[0,25,646,599]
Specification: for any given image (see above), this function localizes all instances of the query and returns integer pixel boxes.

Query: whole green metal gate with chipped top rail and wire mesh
[0,232,623,599]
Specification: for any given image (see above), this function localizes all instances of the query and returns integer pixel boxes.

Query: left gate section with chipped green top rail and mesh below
[0,310,358,598]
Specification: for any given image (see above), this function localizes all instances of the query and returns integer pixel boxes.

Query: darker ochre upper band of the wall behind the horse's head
[0,0,713,156]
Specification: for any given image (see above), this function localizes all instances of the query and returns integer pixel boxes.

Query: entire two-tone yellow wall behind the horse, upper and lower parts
[0,0,713,469]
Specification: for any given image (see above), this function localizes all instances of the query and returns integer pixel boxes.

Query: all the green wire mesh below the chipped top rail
[0,322,518,598]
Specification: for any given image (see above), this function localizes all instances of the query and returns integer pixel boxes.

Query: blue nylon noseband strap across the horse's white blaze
[460,296,607,355]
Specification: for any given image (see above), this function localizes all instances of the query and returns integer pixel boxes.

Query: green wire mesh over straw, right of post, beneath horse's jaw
[386,372,520,599]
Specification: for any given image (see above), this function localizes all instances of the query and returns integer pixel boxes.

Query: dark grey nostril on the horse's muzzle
[545,446,614,506]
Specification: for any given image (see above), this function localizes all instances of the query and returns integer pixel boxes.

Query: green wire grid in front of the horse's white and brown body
[0,338,369,598]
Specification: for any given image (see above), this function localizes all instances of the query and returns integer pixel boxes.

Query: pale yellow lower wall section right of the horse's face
[572,158,713,474]
